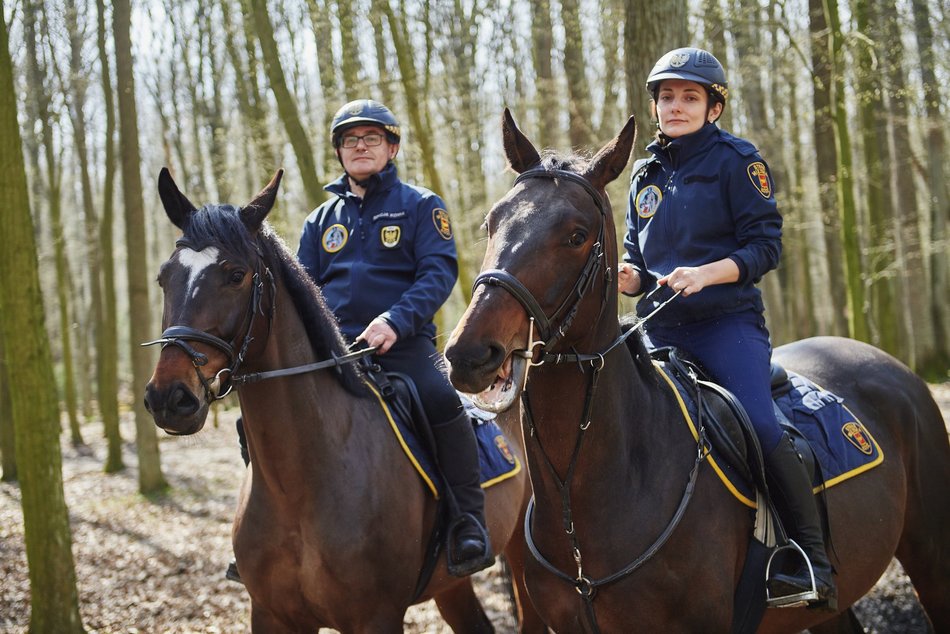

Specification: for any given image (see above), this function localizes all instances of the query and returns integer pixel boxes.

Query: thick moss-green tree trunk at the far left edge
[0,14,85,634]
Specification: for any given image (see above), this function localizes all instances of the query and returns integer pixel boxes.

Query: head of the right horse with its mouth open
[445,109,636,411]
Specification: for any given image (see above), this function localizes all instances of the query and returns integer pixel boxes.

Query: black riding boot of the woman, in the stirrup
[765,433,837,610]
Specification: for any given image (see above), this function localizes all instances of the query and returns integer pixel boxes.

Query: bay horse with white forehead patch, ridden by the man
[145,169,543,634]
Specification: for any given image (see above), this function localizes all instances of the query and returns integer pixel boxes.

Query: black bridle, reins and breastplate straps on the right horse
[473,167,706,632]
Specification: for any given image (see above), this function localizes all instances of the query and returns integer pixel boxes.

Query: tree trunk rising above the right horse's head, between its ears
[561,0,594,150]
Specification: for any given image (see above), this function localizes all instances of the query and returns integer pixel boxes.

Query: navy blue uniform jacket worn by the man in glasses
[297,163,458,340]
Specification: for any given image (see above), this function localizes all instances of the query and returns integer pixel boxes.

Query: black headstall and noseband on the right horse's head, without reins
[472,167,612,358]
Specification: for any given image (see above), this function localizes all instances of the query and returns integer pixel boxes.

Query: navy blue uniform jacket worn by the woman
[624,124,782,326]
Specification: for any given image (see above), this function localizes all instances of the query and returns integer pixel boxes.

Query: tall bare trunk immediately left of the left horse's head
[113,0,168,493]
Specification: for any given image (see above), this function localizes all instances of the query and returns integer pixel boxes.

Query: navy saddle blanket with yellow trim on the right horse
[658,366,884,508]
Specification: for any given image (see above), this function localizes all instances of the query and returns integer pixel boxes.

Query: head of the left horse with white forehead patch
[144,169,283,435]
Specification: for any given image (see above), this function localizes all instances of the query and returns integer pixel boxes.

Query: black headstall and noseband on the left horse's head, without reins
[141,239,276,403]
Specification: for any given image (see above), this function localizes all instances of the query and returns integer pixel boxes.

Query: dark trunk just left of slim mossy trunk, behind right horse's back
[808,0,847,335]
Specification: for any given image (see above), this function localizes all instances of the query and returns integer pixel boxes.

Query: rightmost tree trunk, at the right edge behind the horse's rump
[911,0,950,369]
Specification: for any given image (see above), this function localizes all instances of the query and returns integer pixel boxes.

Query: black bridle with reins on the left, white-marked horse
[140,238,376,403]
